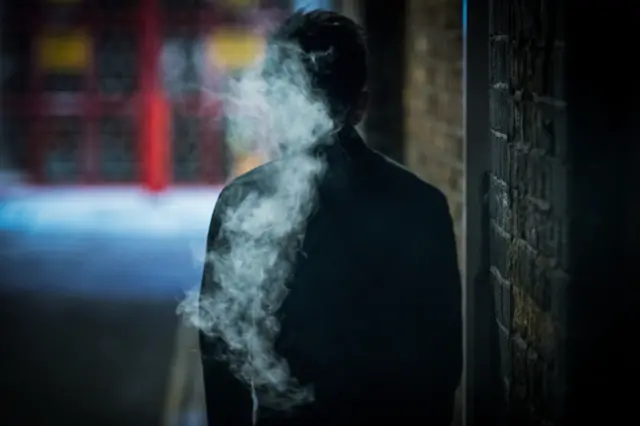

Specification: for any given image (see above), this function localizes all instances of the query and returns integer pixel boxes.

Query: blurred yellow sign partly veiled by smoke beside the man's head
[210,28,265,70]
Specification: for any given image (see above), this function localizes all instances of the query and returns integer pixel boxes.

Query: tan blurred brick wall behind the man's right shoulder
[404,0,464,265]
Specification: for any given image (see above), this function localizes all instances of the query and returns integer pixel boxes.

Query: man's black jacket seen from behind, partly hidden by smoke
[200,129,462,426]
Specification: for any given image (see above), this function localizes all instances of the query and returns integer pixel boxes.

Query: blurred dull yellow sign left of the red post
[37,31,91,72]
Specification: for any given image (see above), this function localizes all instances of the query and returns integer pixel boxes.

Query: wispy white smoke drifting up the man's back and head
[179,40,336,422]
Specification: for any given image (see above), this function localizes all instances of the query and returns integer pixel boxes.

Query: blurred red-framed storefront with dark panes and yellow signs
[0,0,295,190]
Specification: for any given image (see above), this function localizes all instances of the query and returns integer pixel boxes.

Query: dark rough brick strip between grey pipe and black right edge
[489,0,570,426]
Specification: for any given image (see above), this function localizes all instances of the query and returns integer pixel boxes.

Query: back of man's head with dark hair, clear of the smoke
[267,10,368,125]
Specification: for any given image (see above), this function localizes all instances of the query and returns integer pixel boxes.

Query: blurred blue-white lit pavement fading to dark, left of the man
[0,187,219,426]
